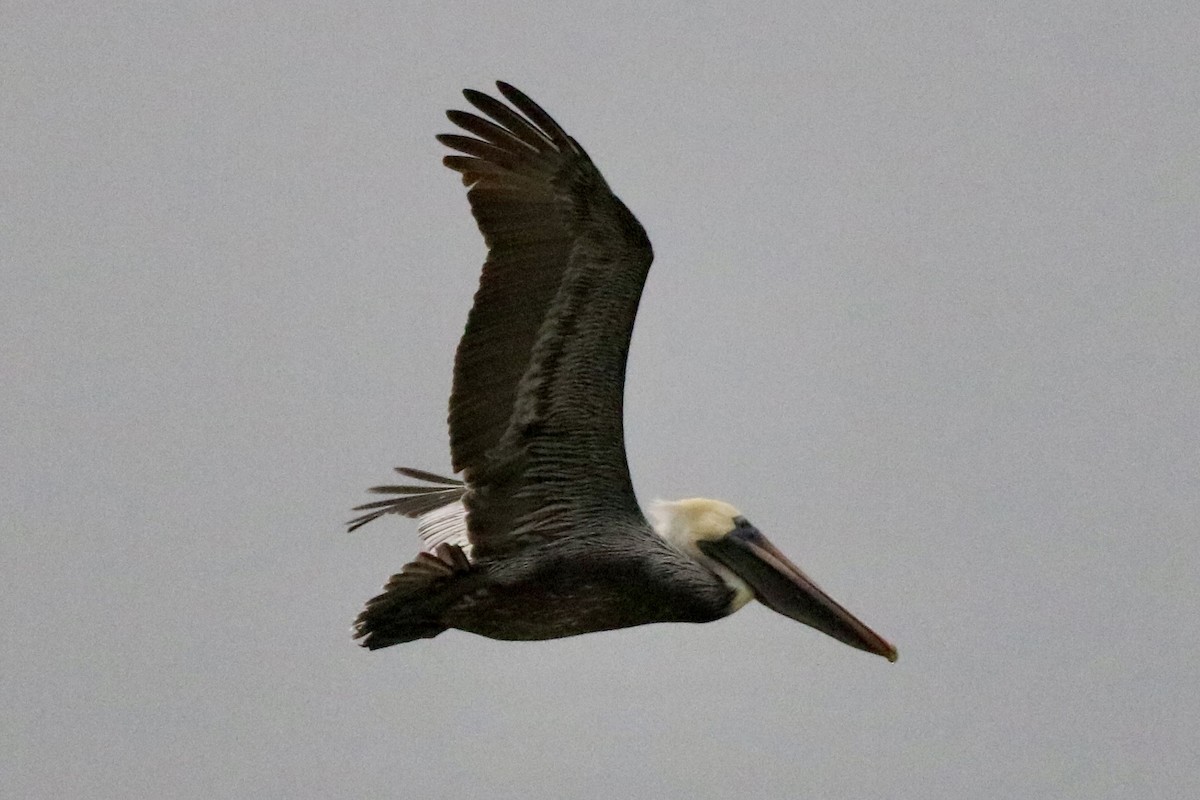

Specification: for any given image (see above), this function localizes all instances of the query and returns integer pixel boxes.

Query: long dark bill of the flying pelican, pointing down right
[697,525,899,661]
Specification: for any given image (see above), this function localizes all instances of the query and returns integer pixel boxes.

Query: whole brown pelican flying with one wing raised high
[349,83,896,661]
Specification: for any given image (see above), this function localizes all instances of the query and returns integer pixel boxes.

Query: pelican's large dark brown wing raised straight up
[438,83,653,557]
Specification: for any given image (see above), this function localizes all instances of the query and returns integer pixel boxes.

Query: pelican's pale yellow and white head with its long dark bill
[650,498,896,661]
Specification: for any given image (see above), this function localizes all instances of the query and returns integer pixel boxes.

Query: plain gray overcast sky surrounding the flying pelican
[0,2,1200,800]
